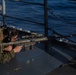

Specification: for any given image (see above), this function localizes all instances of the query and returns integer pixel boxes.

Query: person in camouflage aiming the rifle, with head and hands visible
[0,29,23,63]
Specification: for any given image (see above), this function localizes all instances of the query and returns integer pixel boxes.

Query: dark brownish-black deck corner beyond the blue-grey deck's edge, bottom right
[47,64,76,75]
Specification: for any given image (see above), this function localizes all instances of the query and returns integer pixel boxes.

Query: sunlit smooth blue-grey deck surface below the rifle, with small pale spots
[0,48,62,75]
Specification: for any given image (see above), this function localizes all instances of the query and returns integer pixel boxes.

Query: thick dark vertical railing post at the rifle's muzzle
[44,0,48,52]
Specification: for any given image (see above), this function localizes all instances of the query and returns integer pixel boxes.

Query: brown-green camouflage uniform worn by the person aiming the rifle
[0,29,15,63]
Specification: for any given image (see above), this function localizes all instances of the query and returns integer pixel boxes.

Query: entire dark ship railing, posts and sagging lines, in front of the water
[0,0,76,42]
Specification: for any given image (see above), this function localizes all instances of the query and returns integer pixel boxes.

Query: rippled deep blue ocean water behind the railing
[0,0,76,35]
